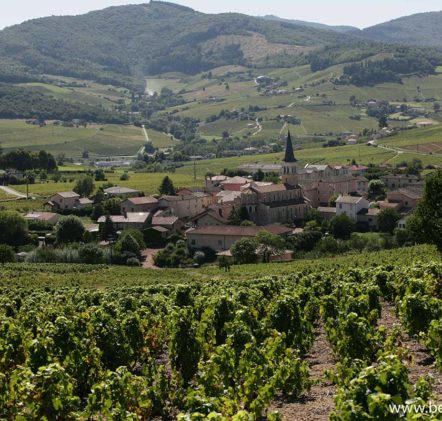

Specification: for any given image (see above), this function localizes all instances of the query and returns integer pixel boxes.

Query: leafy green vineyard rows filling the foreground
[0,260,442,421]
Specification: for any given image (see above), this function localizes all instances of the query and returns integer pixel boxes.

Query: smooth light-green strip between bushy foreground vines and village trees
[0,245,439,288]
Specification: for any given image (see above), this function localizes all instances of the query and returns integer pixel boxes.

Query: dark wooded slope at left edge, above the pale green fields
[0,84,128,124]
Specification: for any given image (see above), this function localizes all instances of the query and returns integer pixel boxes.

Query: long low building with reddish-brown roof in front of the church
[186,225,293,251]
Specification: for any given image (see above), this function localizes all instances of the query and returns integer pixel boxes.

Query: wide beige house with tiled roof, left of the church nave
[158,192,214,218]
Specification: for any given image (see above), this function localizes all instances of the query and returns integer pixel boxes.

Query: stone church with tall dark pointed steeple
[241,131,311,225]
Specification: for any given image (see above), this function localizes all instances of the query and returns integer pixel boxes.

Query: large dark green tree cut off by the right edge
[407,169,442,253]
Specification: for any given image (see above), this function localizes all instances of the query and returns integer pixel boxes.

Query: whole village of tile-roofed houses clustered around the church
[26,133,423,252]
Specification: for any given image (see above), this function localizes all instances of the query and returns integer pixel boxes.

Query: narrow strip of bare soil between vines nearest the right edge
[379,302,442,404]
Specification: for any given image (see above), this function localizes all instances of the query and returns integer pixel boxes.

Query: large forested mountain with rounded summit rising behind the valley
[0,2,352,82]
